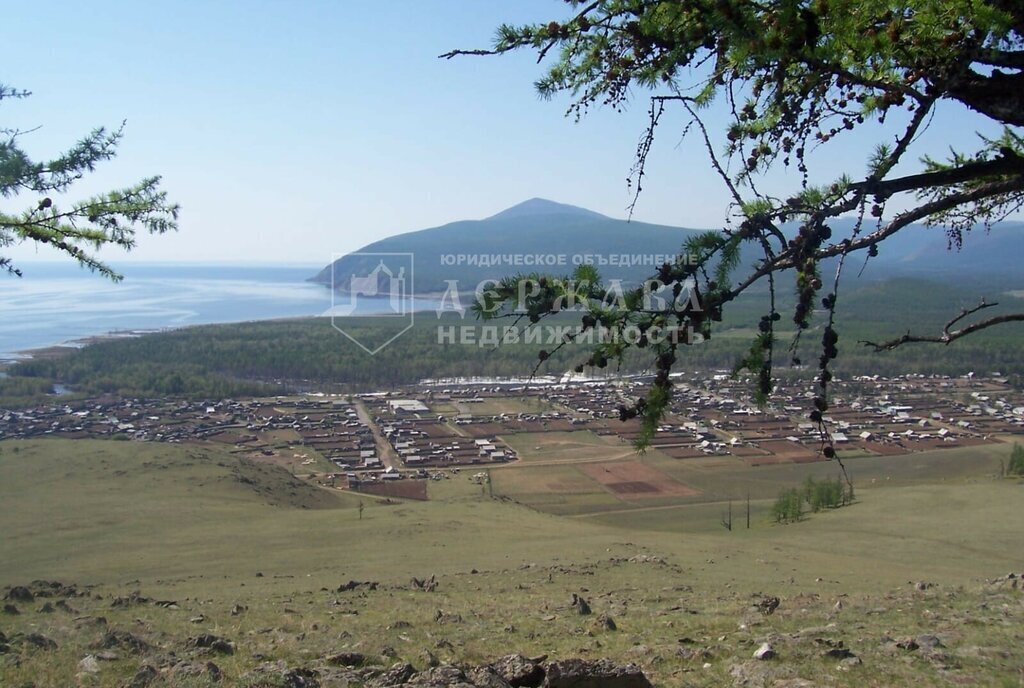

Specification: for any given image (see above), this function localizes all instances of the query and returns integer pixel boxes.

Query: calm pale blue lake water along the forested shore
[0,263,435,359]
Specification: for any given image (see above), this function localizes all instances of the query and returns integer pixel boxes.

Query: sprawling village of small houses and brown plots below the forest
[0,373,1024,499]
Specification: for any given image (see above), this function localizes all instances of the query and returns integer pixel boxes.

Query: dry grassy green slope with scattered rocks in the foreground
[0,440,1024,686]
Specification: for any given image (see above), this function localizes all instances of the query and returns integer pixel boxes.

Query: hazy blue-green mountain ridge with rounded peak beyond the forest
[310,199,1024,296]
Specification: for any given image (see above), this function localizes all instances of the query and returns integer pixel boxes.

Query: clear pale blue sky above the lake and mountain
[0,0,1015,264]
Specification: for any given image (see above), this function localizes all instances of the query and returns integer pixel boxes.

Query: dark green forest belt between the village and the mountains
[0,278,1024,407]
